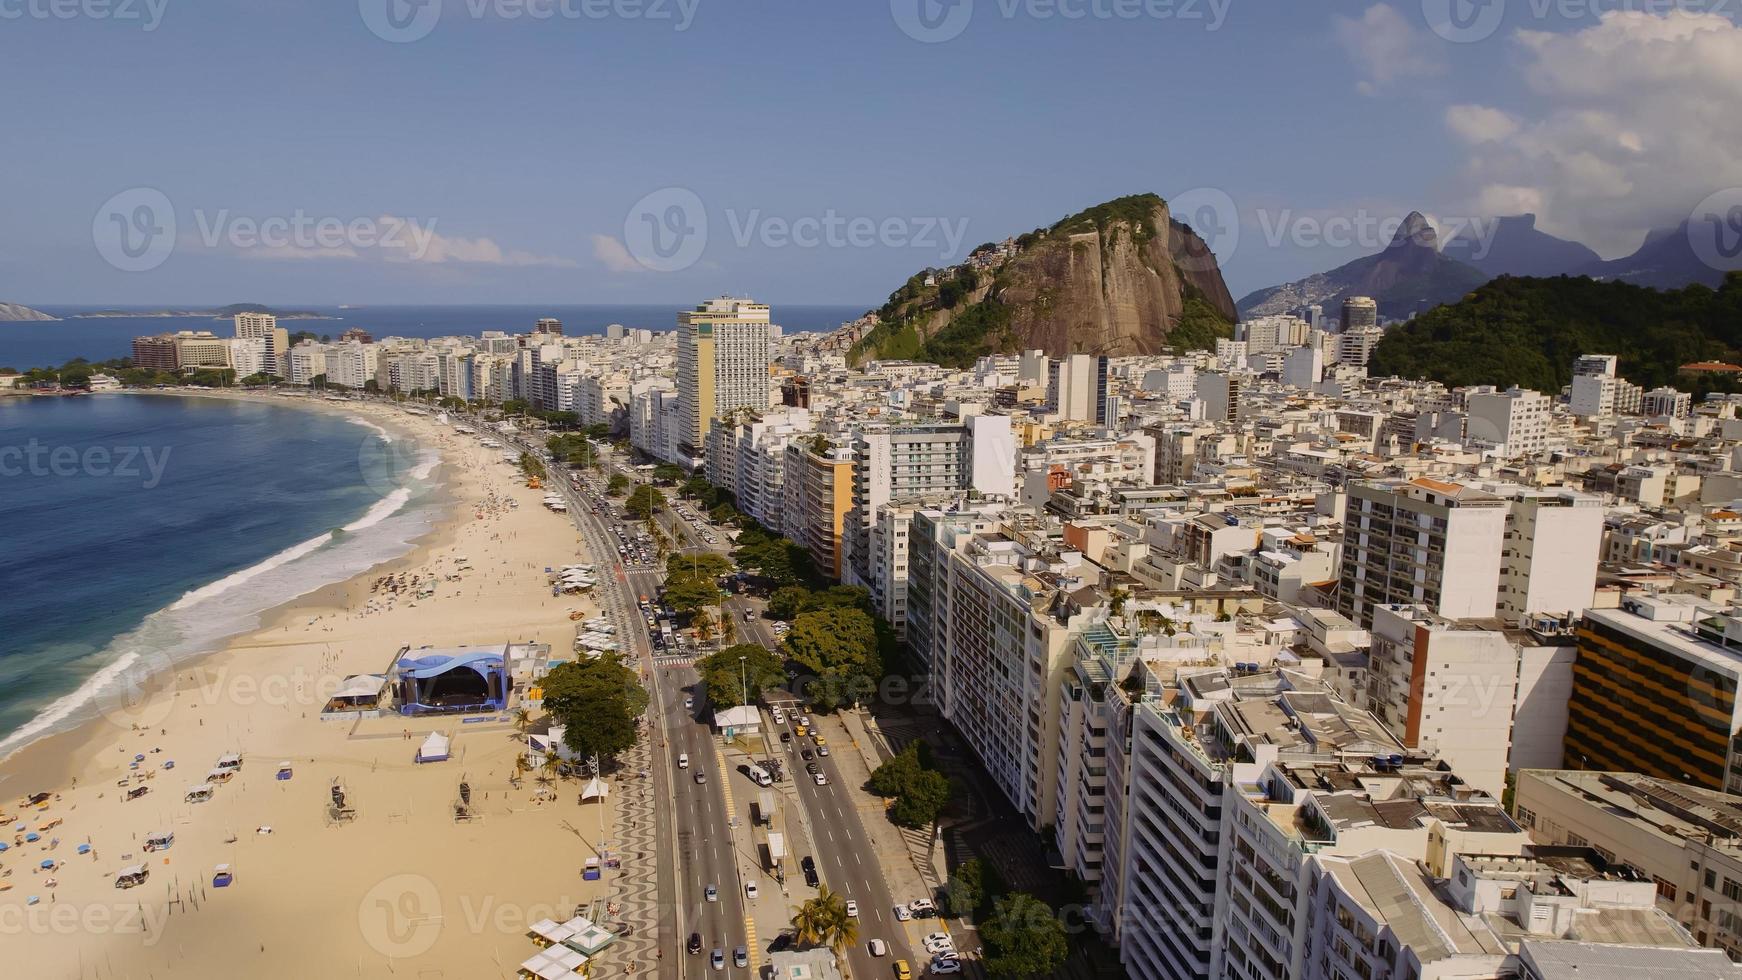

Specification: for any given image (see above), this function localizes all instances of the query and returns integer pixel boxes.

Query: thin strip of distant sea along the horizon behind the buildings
[0,305,868,371]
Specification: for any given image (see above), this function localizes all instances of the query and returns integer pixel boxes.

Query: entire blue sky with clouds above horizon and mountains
[0,0,1742,305]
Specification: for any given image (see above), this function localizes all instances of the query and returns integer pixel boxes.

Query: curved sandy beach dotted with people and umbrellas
[0,399,627,978]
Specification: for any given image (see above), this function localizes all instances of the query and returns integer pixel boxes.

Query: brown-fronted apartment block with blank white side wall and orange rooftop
[1336,477,1509,627]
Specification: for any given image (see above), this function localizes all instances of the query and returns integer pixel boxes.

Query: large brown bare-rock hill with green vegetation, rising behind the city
[841,193,1235,366]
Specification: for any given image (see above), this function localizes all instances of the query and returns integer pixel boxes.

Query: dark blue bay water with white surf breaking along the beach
[0,395,442,757]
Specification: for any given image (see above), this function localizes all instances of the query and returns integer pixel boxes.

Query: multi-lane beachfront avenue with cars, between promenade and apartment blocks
[526,436,935,978]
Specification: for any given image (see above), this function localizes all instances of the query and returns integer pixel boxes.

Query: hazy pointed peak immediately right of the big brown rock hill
[1239,212,1489,320]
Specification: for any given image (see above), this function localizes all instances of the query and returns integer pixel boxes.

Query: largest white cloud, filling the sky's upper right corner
[1446,10,1742,258]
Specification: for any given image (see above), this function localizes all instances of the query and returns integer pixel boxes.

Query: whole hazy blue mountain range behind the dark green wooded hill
[1240,212,1725,320]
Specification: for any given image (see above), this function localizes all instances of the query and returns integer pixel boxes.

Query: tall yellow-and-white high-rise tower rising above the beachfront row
[678,296,770,460]
